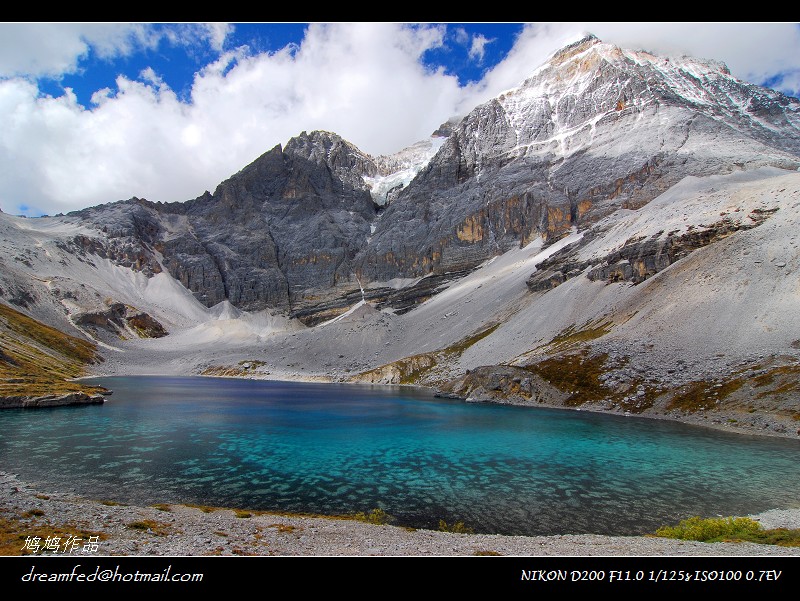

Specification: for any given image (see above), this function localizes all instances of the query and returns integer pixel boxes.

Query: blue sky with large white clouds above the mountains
[0,23,800,216]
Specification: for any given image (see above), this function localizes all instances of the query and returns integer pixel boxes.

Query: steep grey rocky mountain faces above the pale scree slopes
[57,36,800,320]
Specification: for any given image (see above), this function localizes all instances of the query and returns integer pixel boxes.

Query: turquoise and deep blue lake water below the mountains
[0,376,800,535]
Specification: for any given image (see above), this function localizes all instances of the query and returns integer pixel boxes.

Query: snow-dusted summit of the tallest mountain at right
[496,35,800,163]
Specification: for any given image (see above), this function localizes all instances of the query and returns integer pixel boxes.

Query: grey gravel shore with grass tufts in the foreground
[0,472,800,557]
